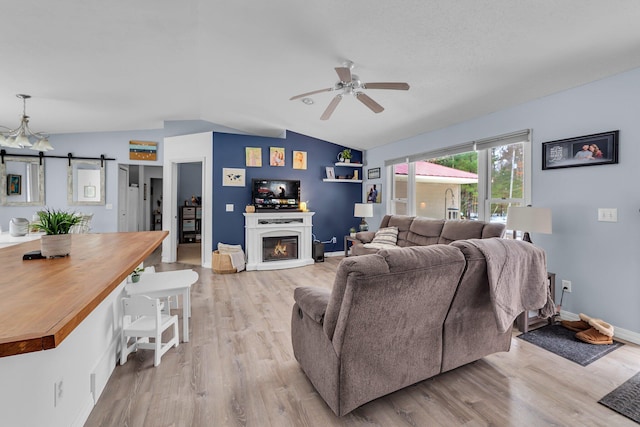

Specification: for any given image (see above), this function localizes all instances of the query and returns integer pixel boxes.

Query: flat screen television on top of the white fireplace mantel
[251,178,300,211]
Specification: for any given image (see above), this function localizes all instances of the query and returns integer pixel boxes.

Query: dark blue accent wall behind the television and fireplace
[213,132,362,252]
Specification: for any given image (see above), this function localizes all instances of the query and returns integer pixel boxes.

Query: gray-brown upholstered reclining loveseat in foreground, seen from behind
[291,239,547,416]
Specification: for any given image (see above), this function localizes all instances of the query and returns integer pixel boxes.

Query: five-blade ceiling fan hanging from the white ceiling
[289,61,409,120]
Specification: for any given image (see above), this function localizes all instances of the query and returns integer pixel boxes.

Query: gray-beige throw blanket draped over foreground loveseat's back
[468,239,555,332]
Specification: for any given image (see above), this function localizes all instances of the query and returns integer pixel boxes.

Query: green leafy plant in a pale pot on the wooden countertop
[33,208,82,258]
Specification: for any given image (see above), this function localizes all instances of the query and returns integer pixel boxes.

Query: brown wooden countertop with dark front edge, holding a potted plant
[0,231,169,357]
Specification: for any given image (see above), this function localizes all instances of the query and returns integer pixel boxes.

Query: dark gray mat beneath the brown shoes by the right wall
[518,325,624,366]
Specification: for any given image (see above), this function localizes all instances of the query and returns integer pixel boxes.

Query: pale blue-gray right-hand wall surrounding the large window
[366,69,640,333]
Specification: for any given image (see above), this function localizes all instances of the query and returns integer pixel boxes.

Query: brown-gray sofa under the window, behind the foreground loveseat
[351,215,505,255]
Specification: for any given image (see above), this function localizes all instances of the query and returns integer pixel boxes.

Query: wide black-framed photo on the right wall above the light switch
[542,130,620,170]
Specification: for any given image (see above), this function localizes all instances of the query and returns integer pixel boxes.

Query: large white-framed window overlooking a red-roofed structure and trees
[386,130,531,223]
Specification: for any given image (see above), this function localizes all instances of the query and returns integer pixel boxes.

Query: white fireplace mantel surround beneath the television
[244,211,315,270]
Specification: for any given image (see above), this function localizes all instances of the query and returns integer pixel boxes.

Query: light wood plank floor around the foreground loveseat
[86,258,640,427]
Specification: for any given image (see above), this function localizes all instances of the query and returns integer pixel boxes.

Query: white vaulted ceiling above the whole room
[0,0,640,149]
